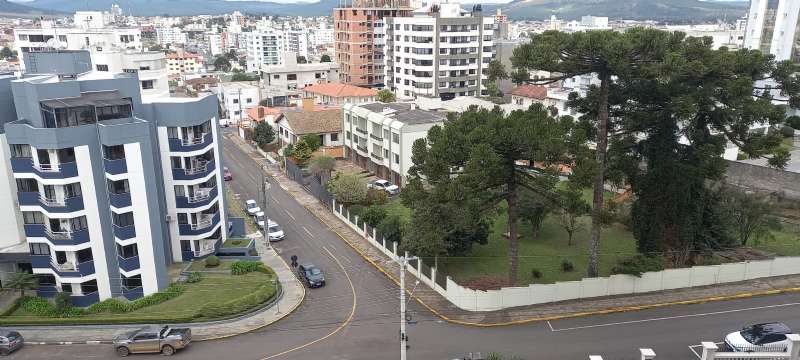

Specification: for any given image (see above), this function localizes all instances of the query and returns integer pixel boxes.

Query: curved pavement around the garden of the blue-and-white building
[15,238,305,344]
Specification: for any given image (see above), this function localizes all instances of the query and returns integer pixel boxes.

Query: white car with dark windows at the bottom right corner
[725,323,792,352]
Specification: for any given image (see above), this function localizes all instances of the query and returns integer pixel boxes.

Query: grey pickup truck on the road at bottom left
[114,326,192,356]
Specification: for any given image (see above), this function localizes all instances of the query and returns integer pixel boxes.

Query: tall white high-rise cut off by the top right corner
[744,0,800,62]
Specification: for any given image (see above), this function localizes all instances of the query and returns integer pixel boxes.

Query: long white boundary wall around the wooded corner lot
[333,200,800,311]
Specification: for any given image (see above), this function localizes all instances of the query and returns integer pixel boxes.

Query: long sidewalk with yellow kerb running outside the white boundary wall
[223,136,800,326]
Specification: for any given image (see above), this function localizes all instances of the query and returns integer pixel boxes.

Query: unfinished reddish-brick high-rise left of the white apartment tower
[333,0,412,87]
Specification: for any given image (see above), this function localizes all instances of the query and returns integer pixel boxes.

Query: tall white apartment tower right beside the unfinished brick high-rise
[383,3,494,100]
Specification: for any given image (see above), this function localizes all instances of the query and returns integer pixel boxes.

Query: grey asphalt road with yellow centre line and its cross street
[13,131,800,360]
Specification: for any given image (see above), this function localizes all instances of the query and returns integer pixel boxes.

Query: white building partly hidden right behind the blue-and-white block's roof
[91,50,169,98]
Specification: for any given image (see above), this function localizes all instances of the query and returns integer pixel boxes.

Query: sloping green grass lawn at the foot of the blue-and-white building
[0,272,275,324]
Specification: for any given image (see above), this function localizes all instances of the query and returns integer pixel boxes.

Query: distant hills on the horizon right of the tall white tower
[500,0,749,23]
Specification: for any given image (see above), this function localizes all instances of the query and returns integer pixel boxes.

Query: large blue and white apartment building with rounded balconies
[0,51,227,305]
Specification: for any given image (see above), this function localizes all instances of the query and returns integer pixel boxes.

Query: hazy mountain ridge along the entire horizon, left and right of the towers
[14,0,748,23]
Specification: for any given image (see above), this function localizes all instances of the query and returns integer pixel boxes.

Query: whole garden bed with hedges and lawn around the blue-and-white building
[0,261,277,325]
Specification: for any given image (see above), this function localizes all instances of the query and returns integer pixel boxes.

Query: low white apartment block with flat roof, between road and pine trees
[342,103,446,186]
